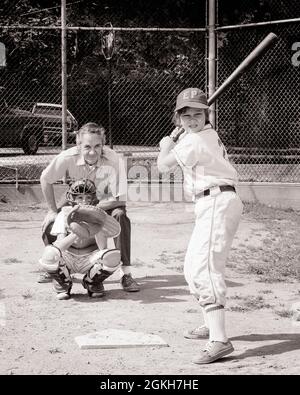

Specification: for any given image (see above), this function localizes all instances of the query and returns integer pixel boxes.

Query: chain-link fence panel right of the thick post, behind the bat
[217,23,300,182]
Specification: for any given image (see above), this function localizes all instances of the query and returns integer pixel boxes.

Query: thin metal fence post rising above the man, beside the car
[61,0,67,150]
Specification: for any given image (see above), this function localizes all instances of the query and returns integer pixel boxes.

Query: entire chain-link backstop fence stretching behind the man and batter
[0,0,300,183]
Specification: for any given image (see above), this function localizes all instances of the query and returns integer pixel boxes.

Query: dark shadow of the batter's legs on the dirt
[230,333,300,359]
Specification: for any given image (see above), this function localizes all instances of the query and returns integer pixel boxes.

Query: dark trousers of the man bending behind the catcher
[42,206,131,266]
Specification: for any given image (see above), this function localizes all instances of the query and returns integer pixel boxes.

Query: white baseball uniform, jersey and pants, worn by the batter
[172,125,243,306]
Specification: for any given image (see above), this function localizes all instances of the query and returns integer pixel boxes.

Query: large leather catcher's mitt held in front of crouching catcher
[67,204,120,238]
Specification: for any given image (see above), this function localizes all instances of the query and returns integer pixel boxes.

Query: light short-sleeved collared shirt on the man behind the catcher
[41,146,127,201]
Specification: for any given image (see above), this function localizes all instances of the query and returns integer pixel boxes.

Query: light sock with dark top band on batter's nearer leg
[204,304,228,343]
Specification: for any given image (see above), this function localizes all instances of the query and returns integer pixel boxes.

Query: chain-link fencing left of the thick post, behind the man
[0,25,206,182]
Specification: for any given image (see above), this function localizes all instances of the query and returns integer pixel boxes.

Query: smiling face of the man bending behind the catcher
[79,133,103,165]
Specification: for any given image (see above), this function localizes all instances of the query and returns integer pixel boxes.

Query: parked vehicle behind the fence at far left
[0,95,78,155]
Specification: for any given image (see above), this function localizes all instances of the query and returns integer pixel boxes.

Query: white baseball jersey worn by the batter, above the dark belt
[172,125,238,197]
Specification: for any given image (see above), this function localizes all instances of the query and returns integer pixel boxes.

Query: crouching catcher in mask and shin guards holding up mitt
[39,179,121,300]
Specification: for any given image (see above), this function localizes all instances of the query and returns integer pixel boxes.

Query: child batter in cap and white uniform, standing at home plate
[157,88,243,364]
